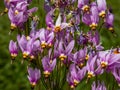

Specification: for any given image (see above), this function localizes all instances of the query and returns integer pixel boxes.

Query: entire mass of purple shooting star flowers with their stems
[4,0,120,90]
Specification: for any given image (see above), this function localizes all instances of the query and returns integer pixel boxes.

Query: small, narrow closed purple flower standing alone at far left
[9,40,18,60]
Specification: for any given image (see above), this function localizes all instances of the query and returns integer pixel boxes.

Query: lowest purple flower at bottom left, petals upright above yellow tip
[28,67,41,86]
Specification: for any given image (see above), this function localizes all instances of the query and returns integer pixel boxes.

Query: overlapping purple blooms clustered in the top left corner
[4,0,37,30]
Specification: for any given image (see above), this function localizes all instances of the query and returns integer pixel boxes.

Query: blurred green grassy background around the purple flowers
[0,0,120,90]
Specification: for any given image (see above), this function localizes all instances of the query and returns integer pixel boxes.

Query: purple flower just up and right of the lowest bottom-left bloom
[42,57,56,77]
